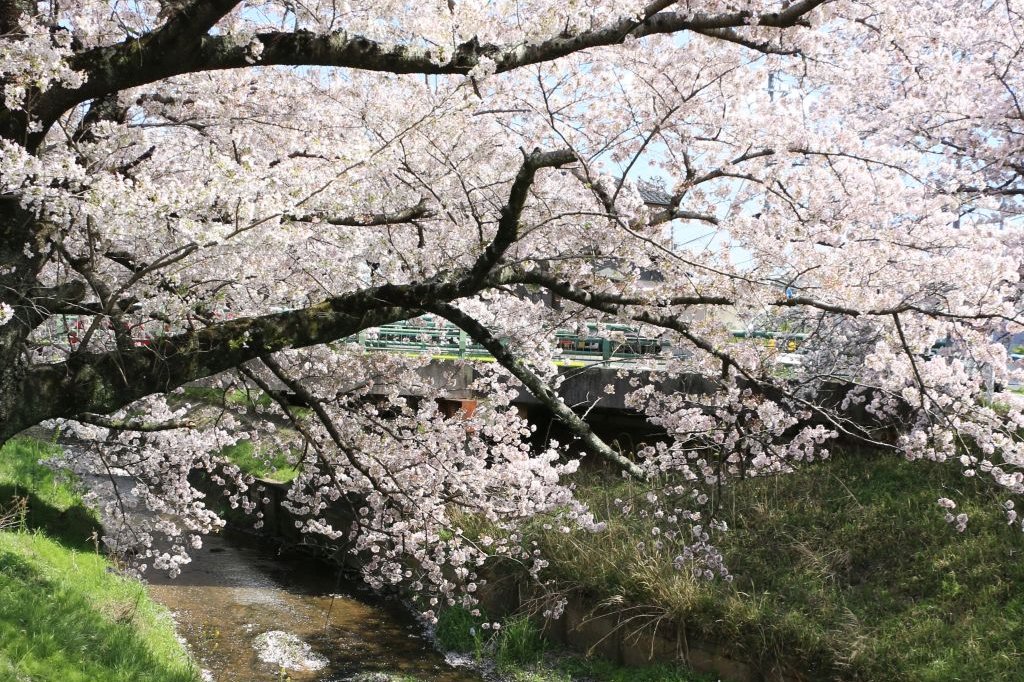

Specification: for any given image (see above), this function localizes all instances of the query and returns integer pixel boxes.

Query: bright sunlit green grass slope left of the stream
[0,439,198,682]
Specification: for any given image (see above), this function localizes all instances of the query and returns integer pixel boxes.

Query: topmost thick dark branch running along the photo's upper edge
[19,0,828,143]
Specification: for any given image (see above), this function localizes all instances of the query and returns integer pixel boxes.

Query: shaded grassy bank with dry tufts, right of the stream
[503,452,1024,682]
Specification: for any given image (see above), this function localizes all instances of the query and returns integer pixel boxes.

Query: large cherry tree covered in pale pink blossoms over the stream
[0,0,1024,607]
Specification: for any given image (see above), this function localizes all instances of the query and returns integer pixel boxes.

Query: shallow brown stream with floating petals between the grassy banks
[150,534,481,682]
